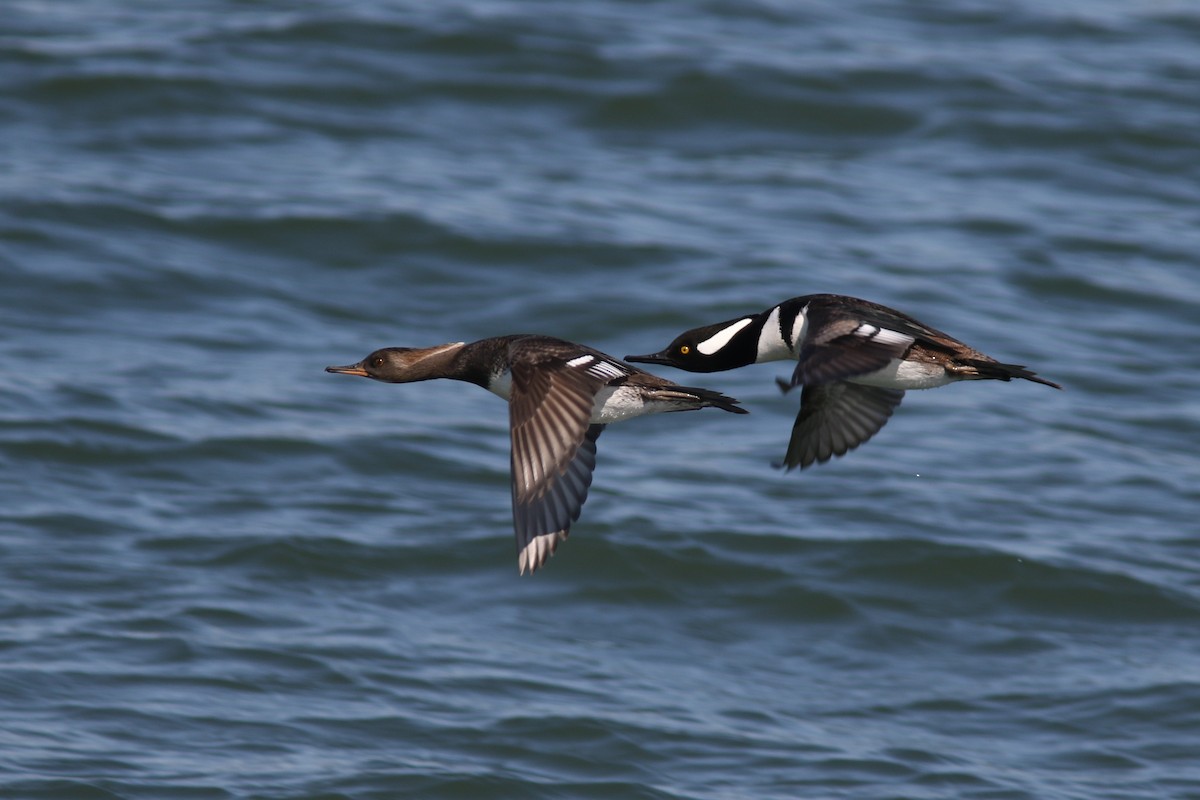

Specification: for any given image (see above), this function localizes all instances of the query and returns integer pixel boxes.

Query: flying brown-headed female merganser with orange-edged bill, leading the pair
[325,335,746,575]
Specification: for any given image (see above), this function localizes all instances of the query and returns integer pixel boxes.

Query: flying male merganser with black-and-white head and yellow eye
[625,294,1062,469]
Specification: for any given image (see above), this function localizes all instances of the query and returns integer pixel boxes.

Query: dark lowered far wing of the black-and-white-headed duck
[782,381,904,469]
